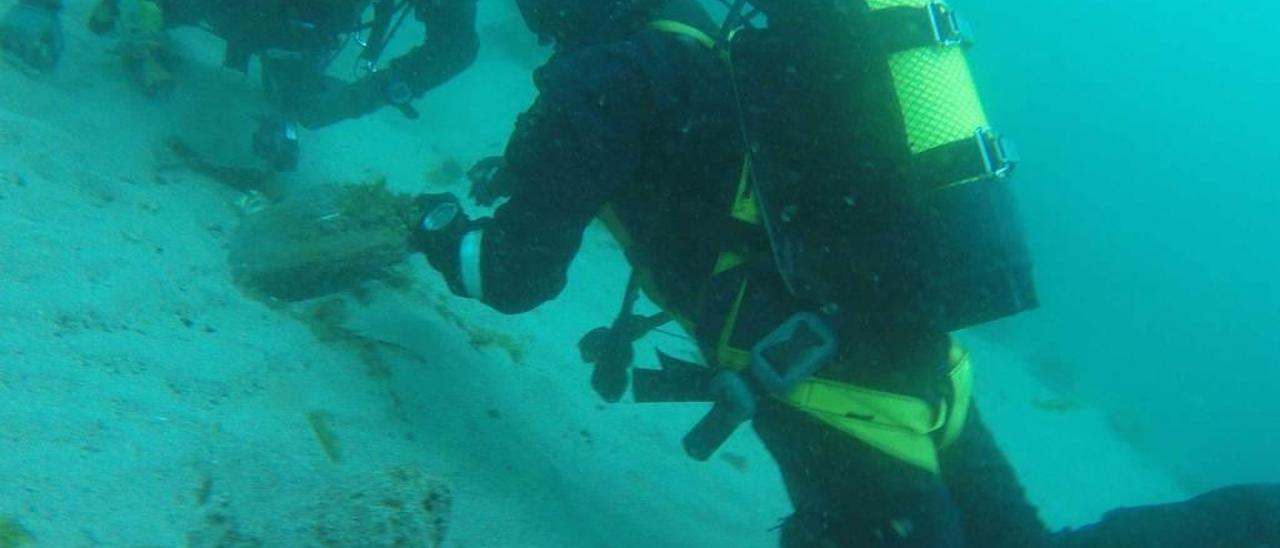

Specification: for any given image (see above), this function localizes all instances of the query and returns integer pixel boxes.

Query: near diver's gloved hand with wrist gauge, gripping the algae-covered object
[410,192,479,294]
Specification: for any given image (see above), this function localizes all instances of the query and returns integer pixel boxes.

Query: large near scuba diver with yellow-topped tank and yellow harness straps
[412,0,1280,547]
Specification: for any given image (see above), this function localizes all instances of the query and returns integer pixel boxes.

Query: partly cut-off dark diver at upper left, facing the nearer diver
[0,0,479,170]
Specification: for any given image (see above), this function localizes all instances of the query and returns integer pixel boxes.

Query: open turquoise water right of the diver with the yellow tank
[955,0,1280,490]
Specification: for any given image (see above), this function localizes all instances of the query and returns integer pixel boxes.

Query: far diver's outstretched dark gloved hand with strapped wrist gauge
[296,72,417,129]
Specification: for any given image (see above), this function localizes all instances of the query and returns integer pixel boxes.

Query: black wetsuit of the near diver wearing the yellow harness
[434,2,1274,547]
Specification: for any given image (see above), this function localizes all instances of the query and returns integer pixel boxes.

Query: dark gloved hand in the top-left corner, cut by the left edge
[0,0,65,70]
